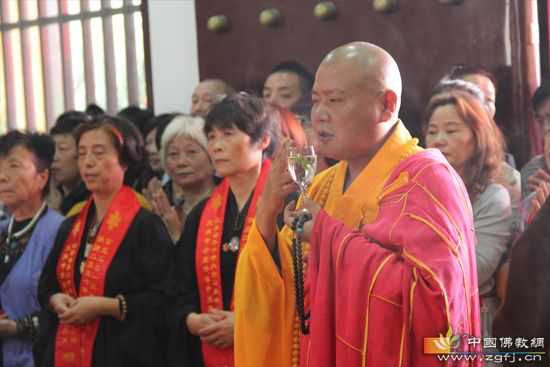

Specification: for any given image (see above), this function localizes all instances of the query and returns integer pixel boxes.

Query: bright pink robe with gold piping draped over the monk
[301,149,483,367]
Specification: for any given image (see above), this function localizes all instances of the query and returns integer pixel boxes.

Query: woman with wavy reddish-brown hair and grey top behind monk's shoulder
[424,91,512,344]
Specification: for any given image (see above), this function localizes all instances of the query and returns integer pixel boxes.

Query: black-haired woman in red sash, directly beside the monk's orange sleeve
[168,93,279,366]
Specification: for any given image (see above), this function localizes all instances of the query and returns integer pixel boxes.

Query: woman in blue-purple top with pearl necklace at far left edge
[0,131,63,366]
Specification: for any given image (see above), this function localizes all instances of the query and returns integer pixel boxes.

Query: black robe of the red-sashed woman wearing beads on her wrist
[33,208,174,367]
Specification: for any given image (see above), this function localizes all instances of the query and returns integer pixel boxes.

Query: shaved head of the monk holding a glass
[311,42,402,165]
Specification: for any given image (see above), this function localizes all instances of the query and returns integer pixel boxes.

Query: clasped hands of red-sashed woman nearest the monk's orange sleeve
[187,309,235,348]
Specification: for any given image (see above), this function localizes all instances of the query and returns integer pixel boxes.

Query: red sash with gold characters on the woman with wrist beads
[55,186,140,367]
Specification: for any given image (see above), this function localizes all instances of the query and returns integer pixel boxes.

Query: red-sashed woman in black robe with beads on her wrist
[34,116,171,366]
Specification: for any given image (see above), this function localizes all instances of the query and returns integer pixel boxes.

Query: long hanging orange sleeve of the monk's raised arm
[235,222,295,366]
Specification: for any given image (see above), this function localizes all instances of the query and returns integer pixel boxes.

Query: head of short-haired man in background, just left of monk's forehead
[262,61,313,109]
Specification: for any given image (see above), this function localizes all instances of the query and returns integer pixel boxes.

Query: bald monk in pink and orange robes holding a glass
[235,42,481,367]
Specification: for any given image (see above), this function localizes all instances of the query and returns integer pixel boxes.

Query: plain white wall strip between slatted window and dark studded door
[148,0,199,114]
